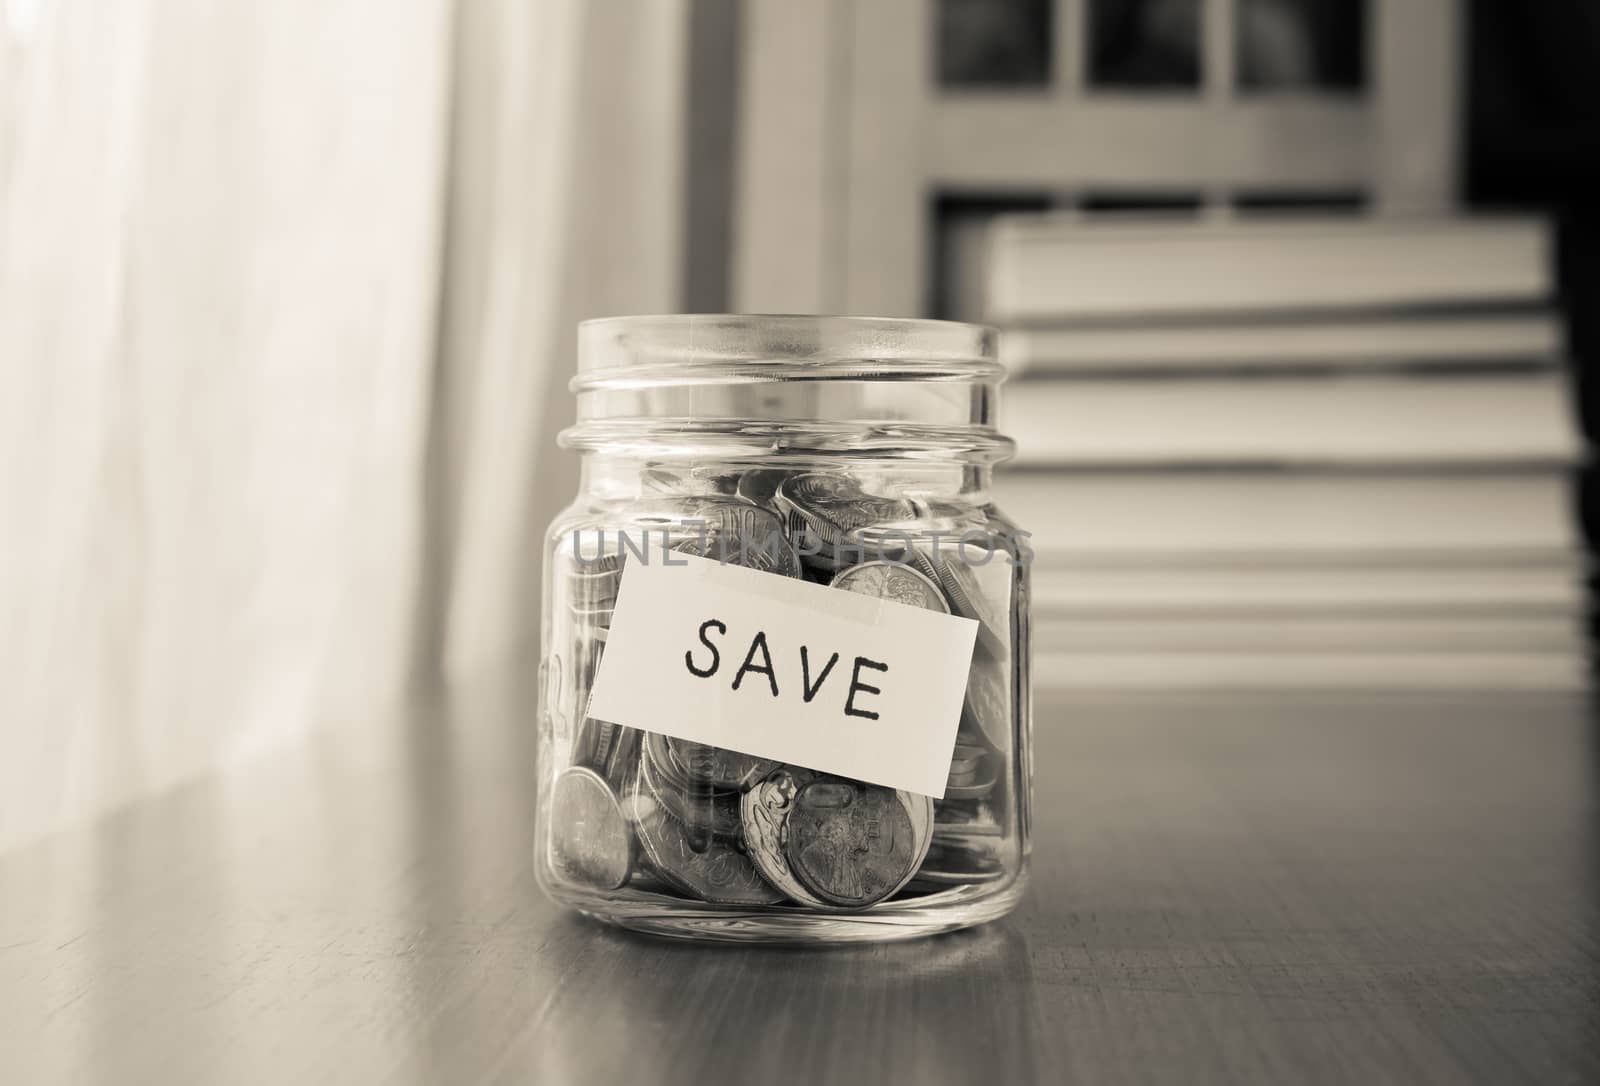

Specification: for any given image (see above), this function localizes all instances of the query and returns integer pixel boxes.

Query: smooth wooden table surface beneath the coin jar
[0,689,1600,1084]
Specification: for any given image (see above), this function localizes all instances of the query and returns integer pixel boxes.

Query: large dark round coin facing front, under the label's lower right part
[784,777,931,908]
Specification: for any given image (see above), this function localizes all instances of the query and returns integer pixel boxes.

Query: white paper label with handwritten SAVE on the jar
[589,555,978,798]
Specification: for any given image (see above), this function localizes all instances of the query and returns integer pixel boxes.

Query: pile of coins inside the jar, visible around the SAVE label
[546,469,1019,910]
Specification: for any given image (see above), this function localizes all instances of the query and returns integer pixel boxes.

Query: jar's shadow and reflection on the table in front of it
[509,916,1048,1083]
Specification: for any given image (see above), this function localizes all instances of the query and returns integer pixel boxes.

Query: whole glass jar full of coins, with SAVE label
[534,315,1032,942]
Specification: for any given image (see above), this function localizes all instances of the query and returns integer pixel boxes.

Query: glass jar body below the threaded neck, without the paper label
[534,447,1032,942]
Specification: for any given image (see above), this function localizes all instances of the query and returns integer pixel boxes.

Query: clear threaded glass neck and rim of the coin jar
[562,313,1011,459]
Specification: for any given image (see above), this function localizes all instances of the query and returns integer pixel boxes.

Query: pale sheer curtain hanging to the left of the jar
[0,0,683,848]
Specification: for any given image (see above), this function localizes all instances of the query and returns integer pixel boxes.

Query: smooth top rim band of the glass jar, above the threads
[571,313,1005,383]
